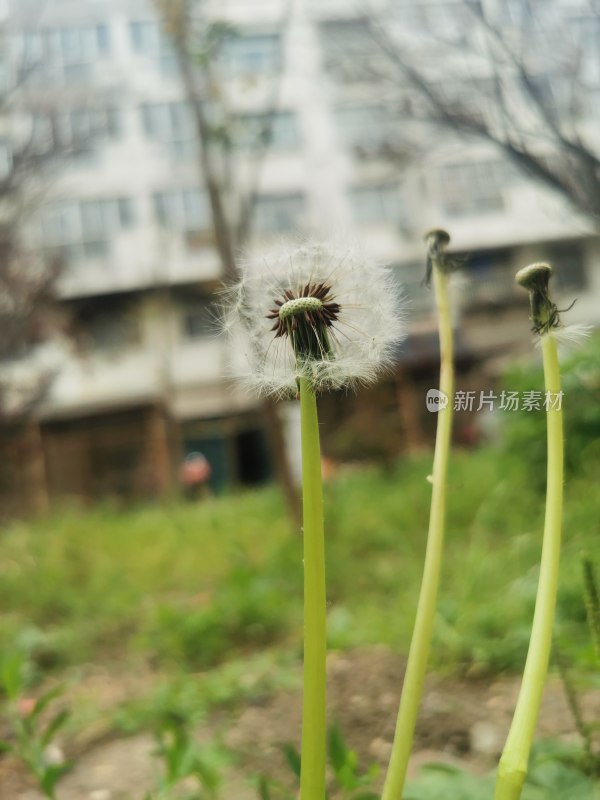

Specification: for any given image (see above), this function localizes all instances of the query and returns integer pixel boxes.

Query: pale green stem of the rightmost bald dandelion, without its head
[494,336,563,800]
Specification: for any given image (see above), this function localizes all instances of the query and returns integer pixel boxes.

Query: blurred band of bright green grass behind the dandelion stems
[0,449,600,684]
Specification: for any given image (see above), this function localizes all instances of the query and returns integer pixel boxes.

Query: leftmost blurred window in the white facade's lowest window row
[41,198,134,260]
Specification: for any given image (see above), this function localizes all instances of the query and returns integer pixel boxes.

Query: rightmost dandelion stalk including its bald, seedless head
[494,263,563,800]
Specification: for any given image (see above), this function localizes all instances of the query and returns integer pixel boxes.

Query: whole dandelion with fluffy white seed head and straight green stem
[225,244,403,800]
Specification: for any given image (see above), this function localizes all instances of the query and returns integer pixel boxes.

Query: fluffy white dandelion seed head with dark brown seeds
[224,242,405,397]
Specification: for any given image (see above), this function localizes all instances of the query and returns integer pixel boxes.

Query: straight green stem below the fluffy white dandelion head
[300,378,327,800]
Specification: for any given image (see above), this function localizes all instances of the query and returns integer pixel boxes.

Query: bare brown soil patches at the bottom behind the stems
[0,647,600,800]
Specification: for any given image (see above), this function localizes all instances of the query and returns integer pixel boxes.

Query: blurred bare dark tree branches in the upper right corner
[330,0,600,225]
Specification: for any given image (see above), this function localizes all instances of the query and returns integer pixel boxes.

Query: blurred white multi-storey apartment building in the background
[0,0,600,506]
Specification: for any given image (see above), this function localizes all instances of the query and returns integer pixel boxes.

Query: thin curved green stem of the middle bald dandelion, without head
[382,265,454,800]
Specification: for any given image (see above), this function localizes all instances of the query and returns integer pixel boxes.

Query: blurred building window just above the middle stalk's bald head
[439,161,508,217]
